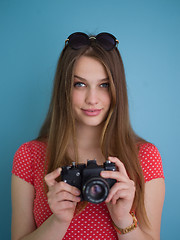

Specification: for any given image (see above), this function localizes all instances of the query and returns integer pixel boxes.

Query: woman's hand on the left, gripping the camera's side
[45,168,81,223]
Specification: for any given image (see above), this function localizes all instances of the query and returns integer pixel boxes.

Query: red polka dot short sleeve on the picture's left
[12,143,34,185]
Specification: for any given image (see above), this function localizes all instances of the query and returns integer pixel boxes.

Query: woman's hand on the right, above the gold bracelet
[101,157,136,225]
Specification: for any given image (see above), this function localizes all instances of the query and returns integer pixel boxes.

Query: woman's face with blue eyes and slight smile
[72,56,111,126]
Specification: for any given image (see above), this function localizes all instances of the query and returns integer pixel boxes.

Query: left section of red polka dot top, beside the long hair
[12,141,52,227]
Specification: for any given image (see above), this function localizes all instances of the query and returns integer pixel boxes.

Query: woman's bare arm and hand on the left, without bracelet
[11,171,79,240]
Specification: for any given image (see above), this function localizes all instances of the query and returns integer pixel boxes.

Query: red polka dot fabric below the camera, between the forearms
[63,203,118,240]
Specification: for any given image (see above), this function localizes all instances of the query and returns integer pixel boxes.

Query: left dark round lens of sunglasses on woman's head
[68,32,89,50]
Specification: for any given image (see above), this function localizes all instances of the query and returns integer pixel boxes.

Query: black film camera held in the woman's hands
[61,160,116,203]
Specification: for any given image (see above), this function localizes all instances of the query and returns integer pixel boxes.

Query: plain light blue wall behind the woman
[0,0,180,240]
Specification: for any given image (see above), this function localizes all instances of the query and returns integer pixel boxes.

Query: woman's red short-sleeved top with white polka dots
[12,141,164,240]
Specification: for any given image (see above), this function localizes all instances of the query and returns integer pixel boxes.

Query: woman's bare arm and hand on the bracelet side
[101,158,165,240]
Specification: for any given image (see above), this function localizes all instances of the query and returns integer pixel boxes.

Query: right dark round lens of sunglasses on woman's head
[96,33,116,51]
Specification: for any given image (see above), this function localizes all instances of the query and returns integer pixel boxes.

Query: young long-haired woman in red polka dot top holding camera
[12,32,165,240]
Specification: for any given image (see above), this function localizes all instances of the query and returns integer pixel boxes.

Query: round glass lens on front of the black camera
[82,178,109,203]
